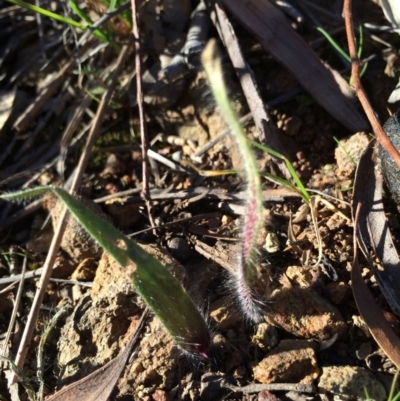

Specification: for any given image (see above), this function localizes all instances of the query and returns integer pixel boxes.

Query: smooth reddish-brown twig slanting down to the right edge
[343,0,400,167]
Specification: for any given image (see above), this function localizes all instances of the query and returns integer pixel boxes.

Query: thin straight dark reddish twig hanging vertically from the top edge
[131,0,155,226]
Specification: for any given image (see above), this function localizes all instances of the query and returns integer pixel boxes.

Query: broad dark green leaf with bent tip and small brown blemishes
[0,186,210,357]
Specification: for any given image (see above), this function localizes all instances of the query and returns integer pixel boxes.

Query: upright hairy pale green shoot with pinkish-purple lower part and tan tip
[202,40,265,321]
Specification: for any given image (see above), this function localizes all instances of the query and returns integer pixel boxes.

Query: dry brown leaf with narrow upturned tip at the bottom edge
[46,309,149,401]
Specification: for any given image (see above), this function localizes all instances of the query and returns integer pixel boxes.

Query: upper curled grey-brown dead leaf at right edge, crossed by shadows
[352,148,400,314]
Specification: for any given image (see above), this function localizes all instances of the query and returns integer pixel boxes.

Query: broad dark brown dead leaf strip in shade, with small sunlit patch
[222,0,367,132]
